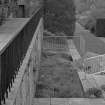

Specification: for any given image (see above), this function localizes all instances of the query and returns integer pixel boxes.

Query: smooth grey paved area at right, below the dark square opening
[75,23,105,56]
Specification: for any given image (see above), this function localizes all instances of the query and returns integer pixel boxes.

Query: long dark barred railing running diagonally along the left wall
[0,9,42,102]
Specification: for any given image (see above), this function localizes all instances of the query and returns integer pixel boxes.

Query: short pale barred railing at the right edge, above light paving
[83,54,105,74]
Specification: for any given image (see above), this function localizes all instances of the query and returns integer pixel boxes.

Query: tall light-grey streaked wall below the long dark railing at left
[3,19,43,105]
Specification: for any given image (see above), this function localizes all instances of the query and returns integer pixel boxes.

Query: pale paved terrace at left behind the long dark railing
[0,18,29,54]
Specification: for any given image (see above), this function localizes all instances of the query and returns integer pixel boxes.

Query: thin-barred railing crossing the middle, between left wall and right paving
[42,34,81,52]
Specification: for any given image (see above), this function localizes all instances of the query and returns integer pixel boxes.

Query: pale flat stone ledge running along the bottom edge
[32,98,105,105]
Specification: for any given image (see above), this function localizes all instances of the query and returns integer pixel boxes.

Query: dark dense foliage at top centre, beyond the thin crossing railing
[44,0,75,36]
